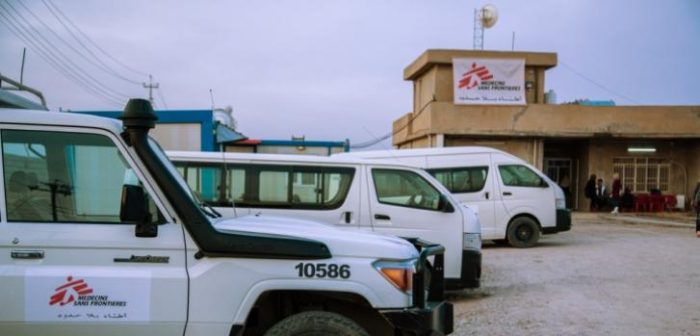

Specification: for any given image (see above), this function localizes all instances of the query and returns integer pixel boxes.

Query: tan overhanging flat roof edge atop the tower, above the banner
[403,49,557,80]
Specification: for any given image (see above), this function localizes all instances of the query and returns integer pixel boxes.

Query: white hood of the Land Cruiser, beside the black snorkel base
[213,215,418,260]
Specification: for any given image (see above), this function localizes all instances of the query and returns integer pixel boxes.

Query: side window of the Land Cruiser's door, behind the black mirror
[2,130,161,223]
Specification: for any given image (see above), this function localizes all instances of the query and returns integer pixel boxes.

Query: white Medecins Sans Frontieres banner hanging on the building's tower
[452,58,526,105]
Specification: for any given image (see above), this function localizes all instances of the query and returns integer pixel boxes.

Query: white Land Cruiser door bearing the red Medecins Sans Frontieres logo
[0,128,187,335]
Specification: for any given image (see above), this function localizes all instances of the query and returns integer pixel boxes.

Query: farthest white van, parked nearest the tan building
[335,146,571,247]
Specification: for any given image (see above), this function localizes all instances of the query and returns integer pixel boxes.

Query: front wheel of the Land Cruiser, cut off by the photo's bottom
[265,311,369,336]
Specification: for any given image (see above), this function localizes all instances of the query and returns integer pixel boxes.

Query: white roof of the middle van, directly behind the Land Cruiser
[166,151,424,169]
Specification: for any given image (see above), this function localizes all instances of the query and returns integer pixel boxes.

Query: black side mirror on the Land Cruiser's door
[119,184,158,238]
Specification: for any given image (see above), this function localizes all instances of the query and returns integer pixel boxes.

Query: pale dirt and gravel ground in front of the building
[448,214,700,335]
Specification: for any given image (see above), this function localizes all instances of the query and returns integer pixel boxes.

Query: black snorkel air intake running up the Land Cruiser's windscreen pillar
[119,99,331,259]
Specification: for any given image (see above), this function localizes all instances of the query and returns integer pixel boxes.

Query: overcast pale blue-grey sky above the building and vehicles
[0,0,700,148]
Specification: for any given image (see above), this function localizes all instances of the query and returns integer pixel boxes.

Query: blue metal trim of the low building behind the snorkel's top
[70,110,218,152]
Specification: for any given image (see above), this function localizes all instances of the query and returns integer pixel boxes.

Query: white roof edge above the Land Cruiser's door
[0,108,122,133]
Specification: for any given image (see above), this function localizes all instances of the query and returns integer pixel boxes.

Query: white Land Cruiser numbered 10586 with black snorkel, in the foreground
[0,100,453,336]
